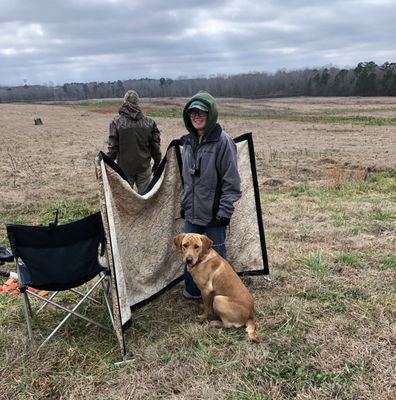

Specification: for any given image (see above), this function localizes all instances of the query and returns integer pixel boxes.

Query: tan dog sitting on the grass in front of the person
[174,233,259,342]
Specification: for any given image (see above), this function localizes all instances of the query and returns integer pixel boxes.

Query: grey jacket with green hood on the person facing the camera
[181,91,241,226]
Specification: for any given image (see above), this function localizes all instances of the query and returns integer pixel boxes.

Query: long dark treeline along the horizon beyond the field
[0,61,396,103]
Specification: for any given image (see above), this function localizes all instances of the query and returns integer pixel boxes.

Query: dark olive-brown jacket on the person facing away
[107,101,161,176]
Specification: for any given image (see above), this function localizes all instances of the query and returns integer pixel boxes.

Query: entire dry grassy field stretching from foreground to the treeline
[0,97,396,400]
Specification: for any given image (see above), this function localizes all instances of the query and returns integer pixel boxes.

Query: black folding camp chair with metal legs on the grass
[6,213,114,349]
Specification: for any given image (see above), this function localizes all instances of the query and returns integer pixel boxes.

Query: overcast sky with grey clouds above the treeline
[0,0,396,85]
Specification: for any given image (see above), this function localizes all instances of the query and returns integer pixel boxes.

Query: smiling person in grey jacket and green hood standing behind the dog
[181,91,242,299]
